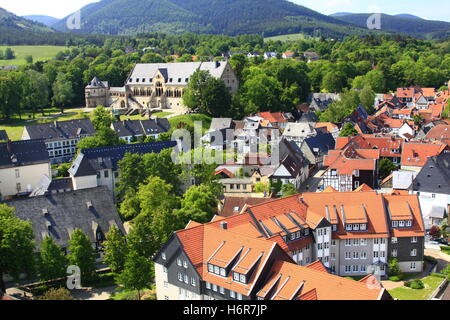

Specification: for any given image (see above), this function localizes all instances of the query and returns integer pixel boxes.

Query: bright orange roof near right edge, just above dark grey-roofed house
[401,142,448,167]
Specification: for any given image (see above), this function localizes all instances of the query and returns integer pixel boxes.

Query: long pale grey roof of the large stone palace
[126,61,227,86]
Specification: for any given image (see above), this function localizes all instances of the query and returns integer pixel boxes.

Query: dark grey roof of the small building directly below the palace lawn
[112,118,170,137]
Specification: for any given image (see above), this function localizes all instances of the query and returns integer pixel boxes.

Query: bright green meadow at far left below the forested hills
[0,46,67,66]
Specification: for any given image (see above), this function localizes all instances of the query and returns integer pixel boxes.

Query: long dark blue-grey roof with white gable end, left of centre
[69,141,177,177]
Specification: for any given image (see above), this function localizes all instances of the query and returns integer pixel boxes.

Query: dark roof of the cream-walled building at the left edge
[0,140,49,168]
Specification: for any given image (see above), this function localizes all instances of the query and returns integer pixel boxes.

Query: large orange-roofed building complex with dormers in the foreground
[155,188,425,300]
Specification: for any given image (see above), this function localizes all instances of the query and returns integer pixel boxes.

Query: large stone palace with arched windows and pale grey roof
[85,61,239,110]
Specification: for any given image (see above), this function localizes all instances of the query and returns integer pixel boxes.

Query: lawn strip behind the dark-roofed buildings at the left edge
[0,109,90,141]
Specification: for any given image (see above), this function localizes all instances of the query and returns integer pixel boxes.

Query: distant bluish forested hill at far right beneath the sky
[332,13,450,39]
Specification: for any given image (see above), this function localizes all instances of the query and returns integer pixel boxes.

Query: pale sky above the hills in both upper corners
[0,0,450,22]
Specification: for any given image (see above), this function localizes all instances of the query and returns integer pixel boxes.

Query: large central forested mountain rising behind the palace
[54,0,367,37]
